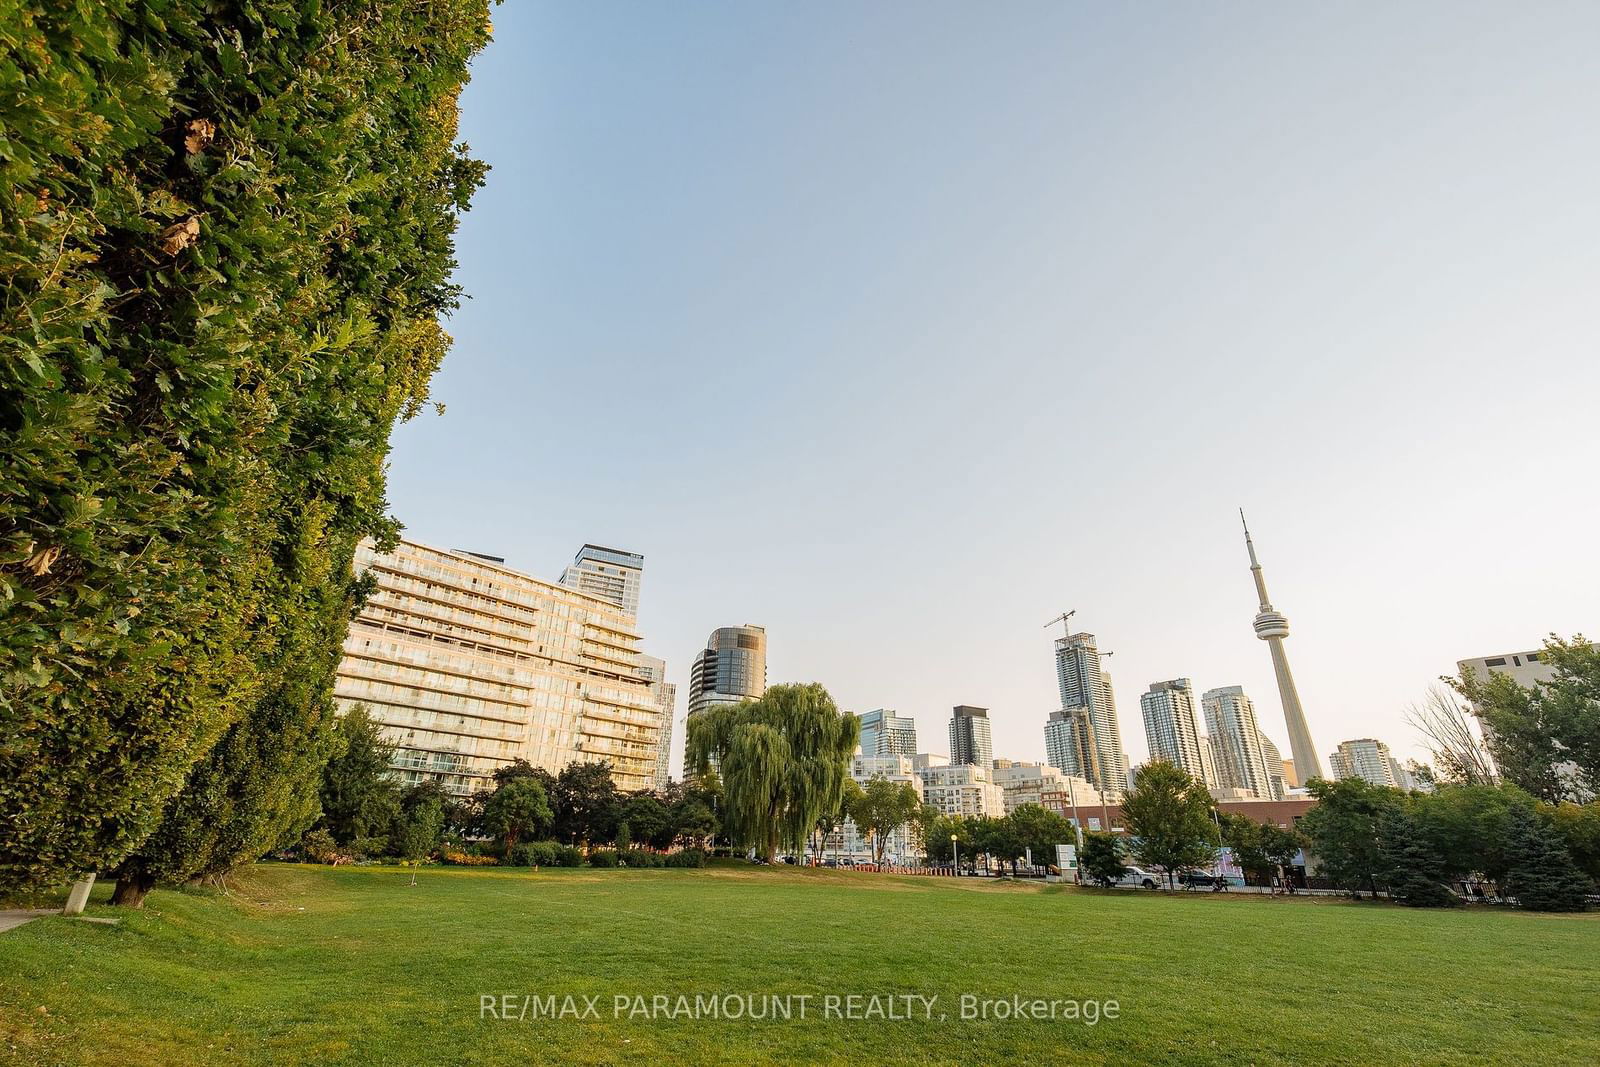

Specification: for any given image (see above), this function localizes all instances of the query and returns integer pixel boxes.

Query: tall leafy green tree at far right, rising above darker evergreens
[1448,635,1600,803]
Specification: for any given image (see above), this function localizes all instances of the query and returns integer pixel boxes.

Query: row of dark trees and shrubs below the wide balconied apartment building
[298,709,720,867]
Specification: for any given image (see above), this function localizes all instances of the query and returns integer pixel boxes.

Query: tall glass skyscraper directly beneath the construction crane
[1045,633,1128,790]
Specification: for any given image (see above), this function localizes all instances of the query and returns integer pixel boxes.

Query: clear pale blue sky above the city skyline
[390,0,1600,773]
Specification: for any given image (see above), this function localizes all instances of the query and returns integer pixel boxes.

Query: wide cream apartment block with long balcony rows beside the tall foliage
[334,541,661,795]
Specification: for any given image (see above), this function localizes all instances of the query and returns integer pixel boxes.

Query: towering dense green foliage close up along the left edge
[0,0,490,902]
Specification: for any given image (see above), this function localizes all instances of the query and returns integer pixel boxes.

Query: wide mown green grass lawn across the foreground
[0,865,1600,1067]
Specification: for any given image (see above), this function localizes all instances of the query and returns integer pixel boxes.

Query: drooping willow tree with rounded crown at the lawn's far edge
[688,681,861,862]
